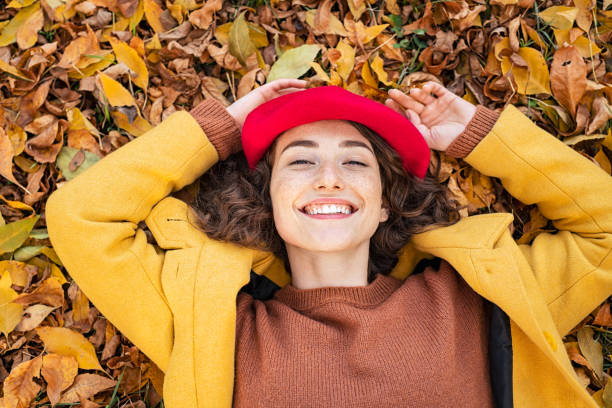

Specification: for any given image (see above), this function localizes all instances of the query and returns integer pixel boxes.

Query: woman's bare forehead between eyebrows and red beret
[276,119,371,151]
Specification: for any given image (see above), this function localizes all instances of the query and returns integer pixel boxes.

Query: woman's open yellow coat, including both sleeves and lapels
[46,106,612,408]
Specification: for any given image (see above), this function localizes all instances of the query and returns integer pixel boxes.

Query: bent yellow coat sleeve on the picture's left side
[46,111,218,371]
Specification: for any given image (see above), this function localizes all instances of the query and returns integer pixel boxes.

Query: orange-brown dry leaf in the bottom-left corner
[3,356,42,408]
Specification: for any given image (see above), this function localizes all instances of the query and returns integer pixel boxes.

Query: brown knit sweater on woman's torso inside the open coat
[233,261,493,408]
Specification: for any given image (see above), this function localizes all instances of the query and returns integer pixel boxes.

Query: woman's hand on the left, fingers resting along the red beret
[227,79,307,131]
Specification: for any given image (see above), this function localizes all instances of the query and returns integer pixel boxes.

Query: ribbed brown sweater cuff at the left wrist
[189,98,242,160]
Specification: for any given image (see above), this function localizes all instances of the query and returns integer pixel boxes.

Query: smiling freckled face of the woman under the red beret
[270,120,388,252]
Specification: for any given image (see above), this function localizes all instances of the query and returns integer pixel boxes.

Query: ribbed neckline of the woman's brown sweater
[274,274,402,310]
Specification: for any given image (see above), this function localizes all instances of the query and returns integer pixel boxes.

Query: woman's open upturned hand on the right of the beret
[385,82,476,151]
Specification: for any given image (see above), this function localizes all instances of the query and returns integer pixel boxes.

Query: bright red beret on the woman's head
[242,86,429,179]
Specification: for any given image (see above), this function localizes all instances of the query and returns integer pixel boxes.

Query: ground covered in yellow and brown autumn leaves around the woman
[0,0,612,408]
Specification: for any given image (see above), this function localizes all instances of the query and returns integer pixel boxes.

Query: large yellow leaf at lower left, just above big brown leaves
[36,326,104,371]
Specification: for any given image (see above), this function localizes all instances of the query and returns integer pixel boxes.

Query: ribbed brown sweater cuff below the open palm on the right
[445,105,499,158]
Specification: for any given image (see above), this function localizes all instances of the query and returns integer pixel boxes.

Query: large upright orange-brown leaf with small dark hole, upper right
[550,46,587,117]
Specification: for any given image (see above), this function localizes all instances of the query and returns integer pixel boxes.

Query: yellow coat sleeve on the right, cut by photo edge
[465,106,612,336]
